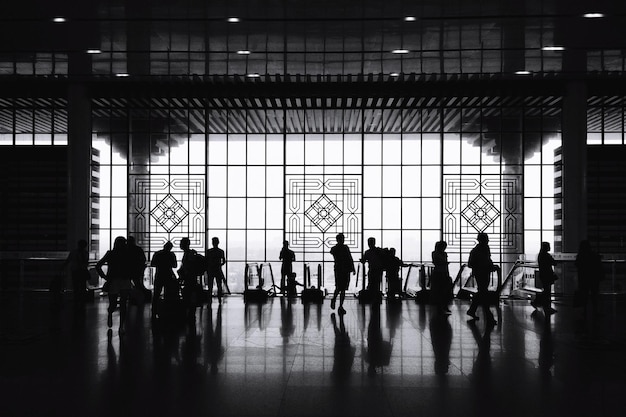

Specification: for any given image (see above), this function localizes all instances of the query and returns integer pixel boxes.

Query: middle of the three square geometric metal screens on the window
[285,174,362,252]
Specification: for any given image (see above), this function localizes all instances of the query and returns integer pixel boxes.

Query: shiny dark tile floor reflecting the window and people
[0,294,626,417]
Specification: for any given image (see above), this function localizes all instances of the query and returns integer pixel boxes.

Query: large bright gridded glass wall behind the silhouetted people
[93,101,560,291]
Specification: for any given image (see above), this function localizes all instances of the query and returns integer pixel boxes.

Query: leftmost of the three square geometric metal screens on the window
[129,174,206,252]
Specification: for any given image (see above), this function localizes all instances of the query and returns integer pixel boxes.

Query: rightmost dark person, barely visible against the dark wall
[576,240,604,317]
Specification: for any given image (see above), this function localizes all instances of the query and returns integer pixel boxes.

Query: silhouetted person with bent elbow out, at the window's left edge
[96,236,131,334]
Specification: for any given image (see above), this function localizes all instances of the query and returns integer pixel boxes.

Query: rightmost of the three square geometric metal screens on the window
[443,174,524,253]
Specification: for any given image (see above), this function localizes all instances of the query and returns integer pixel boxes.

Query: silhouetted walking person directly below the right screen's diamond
[467,233,498,325]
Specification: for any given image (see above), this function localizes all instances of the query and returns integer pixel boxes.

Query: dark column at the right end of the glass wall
[561,82,587,252]
